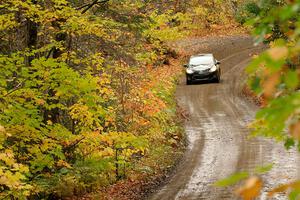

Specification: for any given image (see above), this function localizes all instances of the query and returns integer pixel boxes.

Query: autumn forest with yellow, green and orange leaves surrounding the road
[0,0,300,200]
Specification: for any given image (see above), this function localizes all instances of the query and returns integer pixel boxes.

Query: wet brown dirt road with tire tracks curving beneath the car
[149,36,300,200]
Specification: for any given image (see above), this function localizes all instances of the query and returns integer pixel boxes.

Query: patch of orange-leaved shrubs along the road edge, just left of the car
[119,55,182,133]
